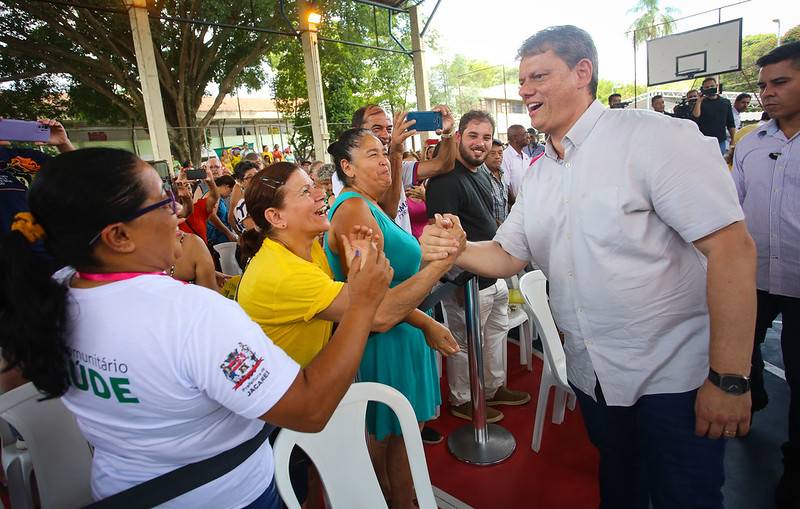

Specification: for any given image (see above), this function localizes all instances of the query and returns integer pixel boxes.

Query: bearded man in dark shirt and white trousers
[425,110,530,423]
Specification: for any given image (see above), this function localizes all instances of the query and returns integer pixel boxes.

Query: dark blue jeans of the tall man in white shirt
[573,383,725,509]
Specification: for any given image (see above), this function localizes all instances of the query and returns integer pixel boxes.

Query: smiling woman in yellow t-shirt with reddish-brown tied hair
[237,162,458,366]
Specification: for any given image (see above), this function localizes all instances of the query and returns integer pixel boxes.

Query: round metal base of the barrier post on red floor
[447,424,517,465]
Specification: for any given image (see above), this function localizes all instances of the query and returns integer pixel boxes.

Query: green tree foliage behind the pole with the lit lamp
[270,0,414,158]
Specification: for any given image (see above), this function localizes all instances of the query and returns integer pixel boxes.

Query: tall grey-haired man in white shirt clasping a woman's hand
[421,26,755,509]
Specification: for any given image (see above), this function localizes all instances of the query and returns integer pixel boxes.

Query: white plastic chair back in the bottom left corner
[0,382,92,509]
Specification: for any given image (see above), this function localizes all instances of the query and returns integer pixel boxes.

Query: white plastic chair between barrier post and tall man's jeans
[519,270,575,452]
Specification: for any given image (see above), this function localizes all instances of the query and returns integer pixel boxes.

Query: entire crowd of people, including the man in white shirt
[0,22,800,509]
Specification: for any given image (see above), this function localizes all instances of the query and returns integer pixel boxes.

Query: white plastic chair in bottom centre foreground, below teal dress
[273,382,436,509]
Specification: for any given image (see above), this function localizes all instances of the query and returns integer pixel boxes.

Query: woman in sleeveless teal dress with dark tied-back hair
[324,129,453,509]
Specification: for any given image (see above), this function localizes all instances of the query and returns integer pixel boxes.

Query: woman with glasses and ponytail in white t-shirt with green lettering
[0,148,392,509]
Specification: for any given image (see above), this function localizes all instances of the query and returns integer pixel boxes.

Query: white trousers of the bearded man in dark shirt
[442,279,508,406]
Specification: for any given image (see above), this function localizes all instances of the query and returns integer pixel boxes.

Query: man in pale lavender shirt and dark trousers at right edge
[732,42,800,509]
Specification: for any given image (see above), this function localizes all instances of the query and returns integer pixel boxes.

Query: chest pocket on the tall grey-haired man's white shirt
[578,186,622,250]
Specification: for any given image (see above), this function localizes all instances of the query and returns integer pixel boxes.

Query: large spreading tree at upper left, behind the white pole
[0,0,285,162]
